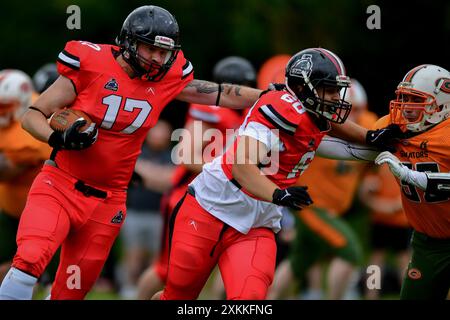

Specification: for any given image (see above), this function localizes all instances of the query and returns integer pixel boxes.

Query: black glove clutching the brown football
[48,119,98,150]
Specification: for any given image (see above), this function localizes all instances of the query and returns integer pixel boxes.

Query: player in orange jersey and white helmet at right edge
[375,64,450,299]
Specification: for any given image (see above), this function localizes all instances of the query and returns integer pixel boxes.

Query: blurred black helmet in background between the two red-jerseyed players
[213,56,256,86]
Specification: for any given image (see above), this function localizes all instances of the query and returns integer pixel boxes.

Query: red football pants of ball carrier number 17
[13,165,126,299]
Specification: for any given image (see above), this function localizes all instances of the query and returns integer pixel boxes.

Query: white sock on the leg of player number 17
[0,267,37,300]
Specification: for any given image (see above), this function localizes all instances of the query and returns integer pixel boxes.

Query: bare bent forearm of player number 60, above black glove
[232,164,278,202]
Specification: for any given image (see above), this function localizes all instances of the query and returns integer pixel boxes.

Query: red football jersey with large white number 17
[55,41,193,190]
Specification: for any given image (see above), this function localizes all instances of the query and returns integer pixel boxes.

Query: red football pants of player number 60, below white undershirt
[161,194,276,300]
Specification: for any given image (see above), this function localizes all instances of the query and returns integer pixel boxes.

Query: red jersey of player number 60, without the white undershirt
[222,90,330,188]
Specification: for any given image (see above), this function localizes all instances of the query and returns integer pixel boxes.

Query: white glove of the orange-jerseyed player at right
[375,151,428,190]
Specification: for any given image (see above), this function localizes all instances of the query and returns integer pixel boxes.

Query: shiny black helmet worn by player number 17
[116,6,181,81]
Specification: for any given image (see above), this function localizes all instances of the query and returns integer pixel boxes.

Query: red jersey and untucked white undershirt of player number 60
[192,91,326,233]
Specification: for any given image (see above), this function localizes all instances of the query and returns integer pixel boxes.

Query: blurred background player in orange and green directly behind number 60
[269,79,377,300]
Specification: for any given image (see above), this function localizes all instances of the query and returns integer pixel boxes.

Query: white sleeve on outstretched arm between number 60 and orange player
[317,136,380,161]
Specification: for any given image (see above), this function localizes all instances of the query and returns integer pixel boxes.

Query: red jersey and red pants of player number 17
[13,41,193,299]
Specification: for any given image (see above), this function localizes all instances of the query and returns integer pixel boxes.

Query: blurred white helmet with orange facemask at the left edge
[0,69,33,127]
